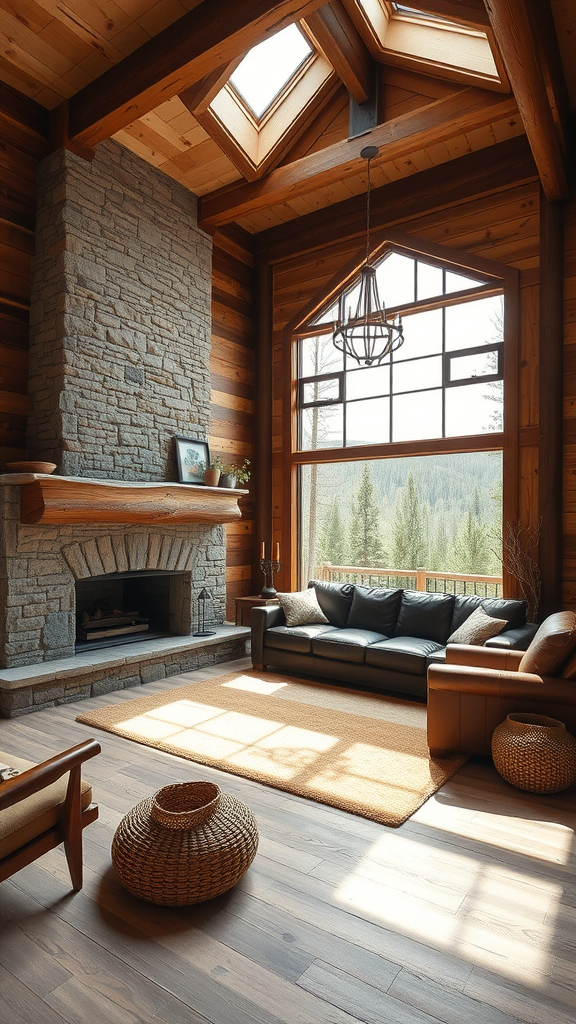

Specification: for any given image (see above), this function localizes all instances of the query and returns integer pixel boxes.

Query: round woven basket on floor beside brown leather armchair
[492,714,576,793]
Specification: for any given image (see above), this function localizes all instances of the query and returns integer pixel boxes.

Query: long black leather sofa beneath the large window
[251,581,537,699]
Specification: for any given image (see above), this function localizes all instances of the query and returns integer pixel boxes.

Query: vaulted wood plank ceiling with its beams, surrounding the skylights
[0,0,576,233]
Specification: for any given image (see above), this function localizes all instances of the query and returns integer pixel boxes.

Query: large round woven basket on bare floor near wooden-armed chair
[112,782,258,906]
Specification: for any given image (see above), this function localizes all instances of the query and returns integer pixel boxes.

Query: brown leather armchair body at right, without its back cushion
[427,644,576,758]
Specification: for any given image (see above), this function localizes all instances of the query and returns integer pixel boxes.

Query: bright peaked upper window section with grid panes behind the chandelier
[298,251,504,451]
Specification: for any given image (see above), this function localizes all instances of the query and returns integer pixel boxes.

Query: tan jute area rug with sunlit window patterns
[77,671,466,826]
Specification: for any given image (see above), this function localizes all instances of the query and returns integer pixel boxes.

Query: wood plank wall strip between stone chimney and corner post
[208,231,253,621]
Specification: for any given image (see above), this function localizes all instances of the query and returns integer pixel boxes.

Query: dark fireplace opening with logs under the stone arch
[76,569,191,653]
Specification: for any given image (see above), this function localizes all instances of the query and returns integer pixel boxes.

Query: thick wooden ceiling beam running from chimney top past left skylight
[69,0,324,147]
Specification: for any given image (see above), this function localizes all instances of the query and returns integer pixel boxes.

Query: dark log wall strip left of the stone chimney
[0,83,48,469]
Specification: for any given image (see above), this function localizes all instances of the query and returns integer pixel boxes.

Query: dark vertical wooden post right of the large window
[538,191,564,616]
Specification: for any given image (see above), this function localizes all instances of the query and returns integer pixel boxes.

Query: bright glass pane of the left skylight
[230,25,312,119]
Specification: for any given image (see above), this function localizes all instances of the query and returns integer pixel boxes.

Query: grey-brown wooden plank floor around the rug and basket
[0,660,576,1024]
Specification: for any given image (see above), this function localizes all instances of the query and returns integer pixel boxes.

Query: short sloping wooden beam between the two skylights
[304,0,372,103]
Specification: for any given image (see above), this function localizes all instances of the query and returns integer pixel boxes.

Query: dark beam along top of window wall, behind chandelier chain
[254,135,538,263]
